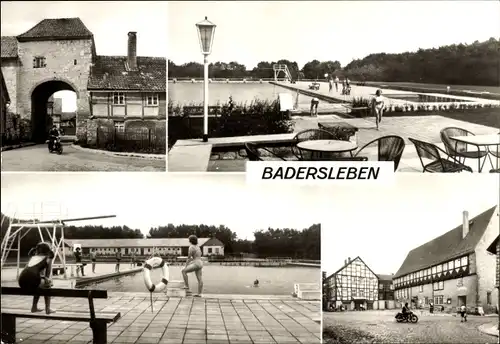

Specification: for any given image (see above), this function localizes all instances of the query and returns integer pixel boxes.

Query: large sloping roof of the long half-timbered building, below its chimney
[393,206,496,278]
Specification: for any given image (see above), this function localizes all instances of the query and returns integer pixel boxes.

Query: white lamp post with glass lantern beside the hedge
[196,17,215,142]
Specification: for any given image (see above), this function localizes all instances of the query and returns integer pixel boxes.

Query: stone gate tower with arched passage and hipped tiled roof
[2,18,96,142]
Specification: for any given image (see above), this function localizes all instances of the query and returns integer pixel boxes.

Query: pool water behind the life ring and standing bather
[83,264,320,295]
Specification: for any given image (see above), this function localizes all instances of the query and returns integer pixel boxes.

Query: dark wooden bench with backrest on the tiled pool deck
[2,287,121,344]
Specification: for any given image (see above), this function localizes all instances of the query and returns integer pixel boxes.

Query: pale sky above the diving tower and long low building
[1,172,321,240]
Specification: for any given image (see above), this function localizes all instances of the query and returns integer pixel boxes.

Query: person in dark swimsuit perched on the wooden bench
[18,242,55,314]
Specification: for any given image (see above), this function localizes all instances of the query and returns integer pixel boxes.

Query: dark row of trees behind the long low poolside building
[1,214,320,260]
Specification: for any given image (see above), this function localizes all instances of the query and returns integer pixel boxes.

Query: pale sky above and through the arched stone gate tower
[1,1,167,111]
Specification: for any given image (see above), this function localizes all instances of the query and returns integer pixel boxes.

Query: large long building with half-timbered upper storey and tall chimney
[394,207,499,312]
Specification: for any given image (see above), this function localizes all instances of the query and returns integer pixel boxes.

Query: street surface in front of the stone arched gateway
[2,144,166,172]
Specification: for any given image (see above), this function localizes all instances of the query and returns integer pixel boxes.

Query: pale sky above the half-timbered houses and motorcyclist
[321,173,499,274]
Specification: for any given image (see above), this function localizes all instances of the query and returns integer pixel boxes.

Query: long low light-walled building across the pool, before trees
[64,238,224,256]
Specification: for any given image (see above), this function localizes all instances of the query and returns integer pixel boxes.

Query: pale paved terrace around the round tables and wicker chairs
[168,115,499,173]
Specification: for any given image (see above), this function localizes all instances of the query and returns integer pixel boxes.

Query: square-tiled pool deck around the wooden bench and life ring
[1,292,321,344]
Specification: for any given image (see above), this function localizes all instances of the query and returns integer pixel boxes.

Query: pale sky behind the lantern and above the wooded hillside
[168,0,500,68]
